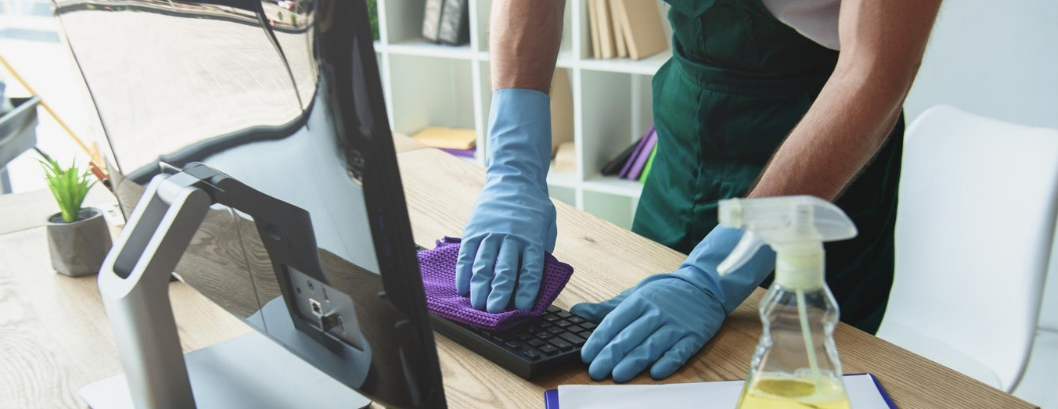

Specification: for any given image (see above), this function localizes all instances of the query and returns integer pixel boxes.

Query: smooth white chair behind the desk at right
[878,106,1058,392]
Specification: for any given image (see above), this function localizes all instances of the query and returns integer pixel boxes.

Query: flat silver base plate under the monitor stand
[78,332,371,409]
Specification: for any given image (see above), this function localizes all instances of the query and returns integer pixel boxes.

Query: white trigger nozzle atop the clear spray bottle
[716,196,856,287]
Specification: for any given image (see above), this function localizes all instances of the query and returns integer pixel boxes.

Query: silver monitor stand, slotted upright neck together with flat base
[79,171,369,409]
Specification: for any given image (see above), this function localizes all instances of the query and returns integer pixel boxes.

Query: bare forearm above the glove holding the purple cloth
[489,0,566,94]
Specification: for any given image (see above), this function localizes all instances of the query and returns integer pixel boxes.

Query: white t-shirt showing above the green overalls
[762,0,841,50]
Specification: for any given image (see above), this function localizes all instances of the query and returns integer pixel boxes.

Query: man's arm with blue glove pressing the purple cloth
[456,0,566,313]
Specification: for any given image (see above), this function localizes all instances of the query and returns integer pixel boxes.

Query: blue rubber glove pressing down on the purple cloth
[456,89,558,313]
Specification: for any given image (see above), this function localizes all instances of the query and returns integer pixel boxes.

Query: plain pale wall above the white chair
[905,0,1058,128]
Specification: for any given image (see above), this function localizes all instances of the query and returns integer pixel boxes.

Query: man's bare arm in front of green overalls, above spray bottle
[749,0,941,200]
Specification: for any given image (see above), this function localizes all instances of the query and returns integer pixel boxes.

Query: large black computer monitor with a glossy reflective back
[55,0,444,408]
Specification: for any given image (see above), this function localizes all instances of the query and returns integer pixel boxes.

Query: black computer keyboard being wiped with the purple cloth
[431,305,596,379]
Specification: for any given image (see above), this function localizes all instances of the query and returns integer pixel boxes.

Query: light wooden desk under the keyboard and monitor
[0,143,1033,409]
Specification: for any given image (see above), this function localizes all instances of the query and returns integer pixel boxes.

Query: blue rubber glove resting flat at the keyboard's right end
[570,226,776,383]
